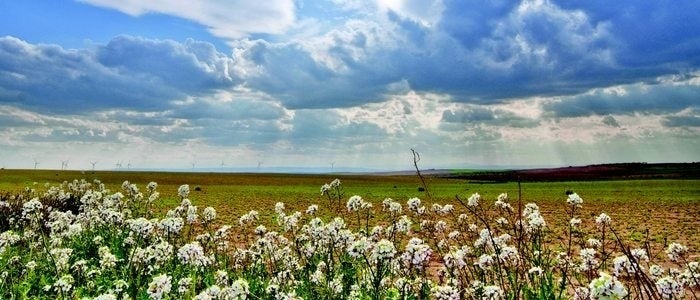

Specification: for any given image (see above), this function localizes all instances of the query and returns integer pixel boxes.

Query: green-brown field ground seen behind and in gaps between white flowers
[0,170,700,299]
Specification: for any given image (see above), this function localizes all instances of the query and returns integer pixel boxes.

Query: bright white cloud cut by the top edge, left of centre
[79,0,295,39]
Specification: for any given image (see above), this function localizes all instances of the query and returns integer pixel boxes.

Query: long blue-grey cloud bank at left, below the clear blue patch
[0,36,236,114]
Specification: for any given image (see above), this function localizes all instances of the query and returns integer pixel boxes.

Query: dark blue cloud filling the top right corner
[558,0,700,68]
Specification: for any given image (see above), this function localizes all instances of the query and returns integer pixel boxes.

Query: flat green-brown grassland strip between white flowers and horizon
[0,170,700,253]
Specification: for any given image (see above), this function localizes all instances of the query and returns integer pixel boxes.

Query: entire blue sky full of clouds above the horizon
[0,0,700,170]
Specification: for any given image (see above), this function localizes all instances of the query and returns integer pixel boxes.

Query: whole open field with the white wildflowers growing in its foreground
[0,170,700,299]
